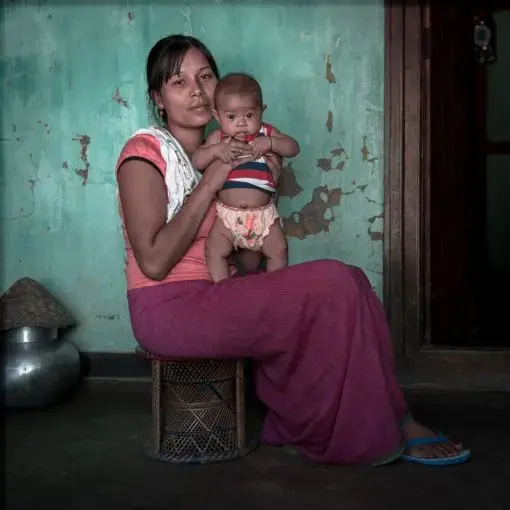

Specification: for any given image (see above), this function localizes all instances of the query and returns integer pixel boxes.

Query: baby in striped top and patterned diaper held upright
[193,73,299,282]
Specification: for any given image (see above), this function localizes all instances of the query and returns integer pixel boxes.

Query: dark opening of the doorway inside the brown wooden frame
[423,7,510,347]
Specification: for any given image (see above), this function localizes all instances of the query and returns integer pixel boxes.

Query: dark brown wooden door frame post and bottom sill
[383,0,510,390]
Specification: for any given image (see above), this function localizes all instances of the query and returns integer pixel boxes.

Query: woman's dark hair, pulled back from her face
[146,34,219,123]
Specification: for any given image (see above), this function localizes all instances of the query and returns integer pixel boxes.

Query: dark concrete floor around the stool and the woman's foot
[5,381,510,510]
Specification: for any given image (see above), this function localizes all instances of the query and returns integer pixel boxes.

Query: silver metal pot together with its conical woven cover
[0,278,81,408]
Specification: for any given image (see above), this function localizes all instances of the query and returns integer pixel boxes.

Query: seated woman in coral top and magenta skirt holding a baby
[117,35,469,464]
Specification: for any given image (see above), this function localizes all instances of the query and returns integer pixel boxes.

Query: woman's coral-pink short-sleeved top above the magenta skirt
[115,134,216,290]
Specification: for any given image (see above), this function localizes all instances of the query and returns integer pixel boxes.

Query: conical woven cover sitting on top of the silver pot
[0,278,76,330]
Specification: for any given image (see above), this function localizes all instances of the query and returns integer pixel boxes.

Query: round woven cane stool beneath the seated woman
[137,348,257,463]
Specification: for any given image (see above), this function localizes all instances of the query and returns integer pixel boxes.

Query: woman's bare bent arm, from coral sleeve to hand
[118,160,232,280]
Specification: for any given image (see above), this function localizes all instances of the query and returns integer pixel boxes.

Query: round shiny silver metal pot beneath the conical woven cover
[1,327,81,408]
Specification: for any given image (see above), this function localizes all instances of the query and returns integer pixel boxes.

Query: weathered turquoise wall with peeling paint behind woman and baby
[0,0,384,351]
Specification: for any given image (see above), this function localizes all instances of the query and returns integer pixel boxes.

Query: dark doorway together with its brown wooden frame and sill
[384,0,510,391]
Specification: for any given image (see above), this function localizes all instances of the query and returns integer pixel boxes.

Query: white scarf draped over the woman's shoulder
[131,126,201,223]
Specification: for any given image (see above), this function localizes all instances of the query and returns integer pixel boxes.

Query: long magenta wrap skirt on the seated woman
[128,260,408,464]
